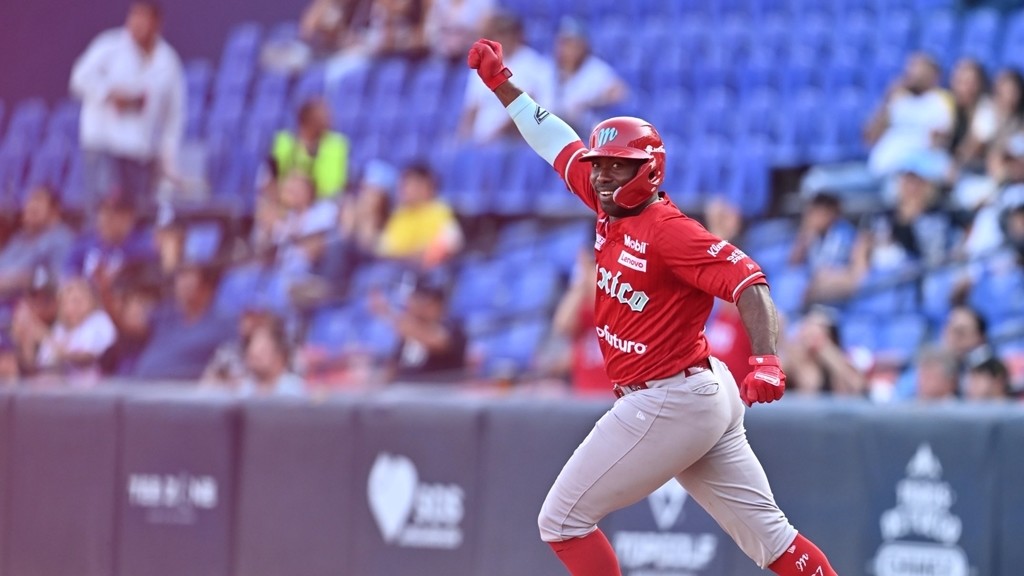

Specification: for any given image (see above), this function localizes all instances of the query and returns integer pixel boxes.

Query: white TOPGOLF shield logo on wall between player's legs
[612,480,718,576]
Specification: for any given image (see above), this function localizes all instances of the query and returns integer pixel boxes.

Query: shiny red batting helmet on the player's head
[580,116,665,208]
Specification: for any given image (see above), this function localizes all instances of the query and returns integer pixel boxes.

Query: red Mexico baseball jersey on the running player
[555,141,766,384]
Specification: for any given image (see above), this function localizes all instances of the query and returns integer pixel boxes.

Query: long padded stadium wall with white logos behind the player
[0,388,1024,576]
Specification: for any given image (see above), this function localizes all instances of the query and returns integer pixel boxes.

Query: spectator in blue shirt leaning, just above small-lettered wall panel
[131,263,232,380]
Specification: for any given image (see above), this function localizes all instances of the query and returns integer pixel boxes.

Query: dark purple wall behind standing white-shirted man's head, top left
[0,0,296,107]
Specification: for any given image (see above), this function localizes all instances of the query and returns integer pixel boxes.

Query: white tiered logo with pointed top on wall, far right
[874,443,971,576]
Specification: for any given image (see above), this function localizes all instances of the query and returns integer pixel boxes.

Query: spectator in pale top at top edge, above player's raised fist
[424,0,496,63]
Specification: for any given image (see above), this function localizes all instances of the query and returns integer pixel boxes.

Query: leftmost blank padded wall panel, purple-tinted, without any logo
[4,390,119,576]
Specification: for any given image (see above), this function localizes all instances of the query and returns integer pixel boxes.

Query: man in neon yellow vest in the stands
[272,98,348,199]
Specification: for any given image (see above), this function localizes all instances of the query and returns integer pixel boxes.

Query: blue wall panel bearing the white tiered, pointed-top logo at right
[861,407,997,576]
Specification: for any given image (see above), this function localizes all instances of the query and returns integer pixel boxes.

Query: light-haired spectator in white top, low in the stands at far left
[33,278,117,376]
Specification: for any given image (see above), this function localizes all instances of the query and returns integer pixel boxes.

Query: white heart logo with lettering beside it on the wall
[367,452,465,549]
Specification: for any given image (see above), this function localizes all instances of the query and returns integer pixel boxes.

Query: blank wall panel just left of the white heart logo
[234,399,366,576]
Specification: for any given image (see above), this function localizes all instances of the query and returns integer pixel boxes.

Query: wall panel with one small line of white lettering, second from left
[117,395,239,576]
